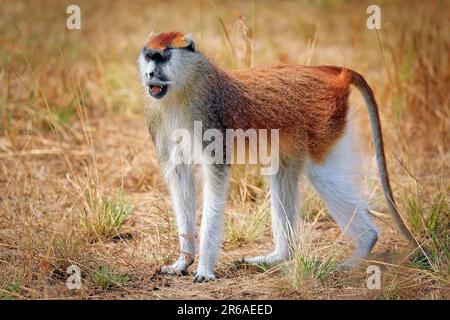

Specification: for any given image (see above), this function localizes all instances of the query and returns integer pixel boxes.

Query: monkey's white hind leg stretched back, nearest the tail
[307,132,378,269]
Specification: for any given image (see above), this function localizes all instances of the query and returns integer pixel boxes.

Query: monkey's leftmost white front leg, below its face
[161,164,195,275]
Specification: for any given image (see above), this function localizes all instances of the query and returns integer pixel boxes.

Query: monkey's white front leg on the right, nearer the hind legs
[194,165,229,282]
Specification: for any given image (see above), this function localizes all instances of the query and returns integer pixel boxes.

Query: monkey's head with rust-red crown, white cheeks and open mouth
[138,32,202,99]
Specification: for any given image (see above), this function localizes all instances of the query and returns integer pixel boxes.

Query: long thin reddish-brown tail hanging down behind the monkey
[349,70,420,248]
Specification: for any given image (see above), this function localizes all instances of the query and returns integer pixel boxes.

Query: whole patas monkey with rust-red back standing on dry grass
[138,32,417,281]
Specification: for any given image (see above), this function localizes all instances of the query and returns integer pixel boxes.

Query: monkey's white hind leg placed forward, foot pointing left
[245,160,303,265]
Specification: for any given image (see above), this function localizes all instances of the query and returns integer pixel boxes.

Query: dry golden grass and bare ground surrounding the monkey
[0,0,450,299]
